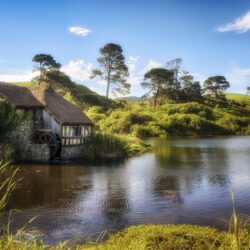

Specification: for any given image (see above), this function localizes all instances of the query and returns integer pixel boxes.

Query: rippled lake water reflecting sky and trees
[5,136,250,243]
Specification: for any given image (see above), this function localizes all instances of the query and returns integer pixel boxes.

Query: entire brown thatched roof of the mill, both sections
[0,83,93,125]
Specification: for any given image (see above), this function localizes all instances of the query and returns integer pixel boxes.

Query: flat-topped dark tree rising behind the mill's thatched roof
[32,54,61,84]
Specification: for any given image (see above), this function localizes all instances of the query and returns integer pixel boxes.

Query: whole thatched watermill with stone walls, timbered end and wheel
[0,83,93,161]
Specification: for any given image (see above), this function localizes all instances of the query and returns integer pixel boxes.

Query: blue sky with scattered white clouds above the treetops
[0,0,250,96]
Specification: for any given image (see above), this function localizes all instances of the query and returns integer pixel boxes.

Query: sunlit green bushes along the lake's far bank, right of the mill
[87,102,250,139]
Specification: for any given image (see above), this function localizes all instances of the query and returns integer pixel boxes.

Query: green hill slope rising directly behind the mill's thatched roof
[15,82,113,108]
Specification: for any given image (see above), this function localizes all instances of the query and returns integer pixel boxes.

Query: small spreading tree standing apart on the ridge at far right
[204,76,230,99]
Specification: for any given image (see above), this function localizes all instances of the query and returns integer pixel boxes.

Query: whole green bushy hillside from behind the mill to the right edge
[15,82,250,139]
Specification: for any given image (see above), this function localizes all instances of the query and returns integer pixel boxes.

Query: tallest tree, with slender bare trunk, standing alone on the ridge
[91,43,130,98]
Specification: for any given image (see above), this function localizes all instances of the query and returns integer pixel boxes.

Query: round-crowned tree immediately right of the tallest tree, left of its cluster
[141,68,174,107]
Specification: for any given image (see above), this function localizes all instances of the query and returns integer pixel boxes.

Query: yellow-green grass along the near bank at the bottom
[0,225,250,250]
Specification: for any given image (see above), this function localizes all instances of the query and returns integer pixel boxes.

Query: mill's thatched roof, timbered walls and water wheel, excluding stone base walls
[0,83,93,158]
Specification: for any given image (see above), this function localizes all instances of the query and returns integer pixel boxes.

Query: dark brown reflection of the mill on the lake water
[8,166,93,210]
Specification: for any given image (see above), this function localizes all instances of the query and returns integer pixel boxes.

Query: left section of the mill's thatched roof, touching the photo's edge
[0,82,43,108]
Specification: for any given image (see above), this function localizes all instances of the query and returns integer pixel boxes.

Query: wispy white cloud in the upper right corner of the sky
[216,11,250,33]
